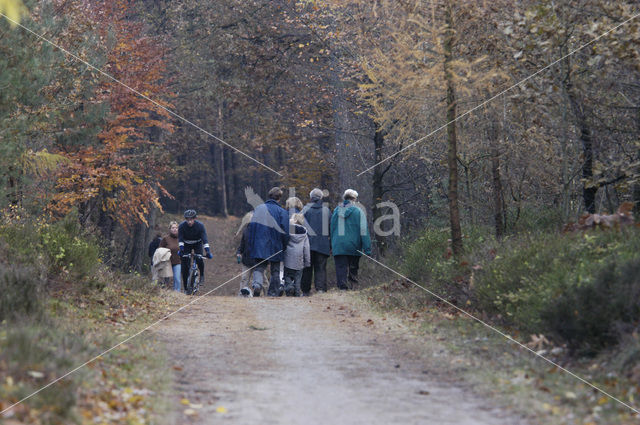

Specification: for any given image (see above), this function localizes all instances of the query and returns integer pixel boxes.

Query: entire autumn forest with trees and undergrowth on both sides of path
[0,0,640,424]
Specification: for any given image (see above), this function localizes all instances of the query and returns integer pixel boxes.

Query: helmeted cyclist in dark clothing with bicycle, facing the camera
[178,210,213,295]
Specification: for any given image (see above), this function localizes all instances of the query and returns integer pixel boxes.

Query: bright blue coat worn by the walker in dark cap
[247,199,289,261]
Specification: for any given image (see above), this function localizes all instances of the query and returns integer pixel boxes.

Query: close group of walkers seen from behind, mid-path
[237,187,371,297]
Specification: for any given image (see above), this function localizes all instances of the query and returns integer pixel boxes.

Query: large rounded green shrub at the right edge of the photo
[474,229,640,350]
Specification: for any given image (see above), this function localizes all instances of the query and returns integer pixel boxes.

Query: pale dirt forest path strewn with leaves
[155,219,523,425]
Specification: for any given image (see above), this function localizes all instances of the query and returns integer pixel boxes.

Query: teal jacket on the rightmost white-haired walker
[331,201,371,256]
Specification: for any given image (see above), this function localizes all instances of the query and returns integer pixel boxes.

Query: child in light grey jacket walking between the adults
[284,214,311,297]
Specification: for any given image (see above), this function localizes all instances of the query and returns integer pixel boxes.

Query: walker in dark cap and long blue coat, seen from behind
[247,187,289,297]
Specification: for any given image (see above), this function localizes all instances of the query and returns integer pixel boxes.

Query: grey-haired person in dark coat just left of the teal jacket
[301,188,331,296]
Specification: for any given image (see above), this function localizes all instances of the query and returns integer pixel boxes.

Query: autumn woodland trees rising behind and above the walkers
[0,0,640,269]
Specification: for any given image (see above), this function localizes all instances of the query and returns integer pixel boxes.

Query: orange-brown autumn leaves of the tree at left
[49,0,173,228]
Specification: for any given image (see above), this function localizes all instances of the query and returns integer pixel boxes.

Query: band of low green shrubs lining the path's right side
[402,213,640,354]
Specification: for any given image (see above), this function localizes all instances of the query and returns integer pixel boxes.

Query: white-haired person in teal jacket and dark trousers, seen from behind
[331,189,371,290]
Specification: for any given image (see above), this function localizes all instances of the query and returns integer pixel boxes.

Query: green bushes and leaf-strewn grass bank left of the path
[0,209,174,424]
